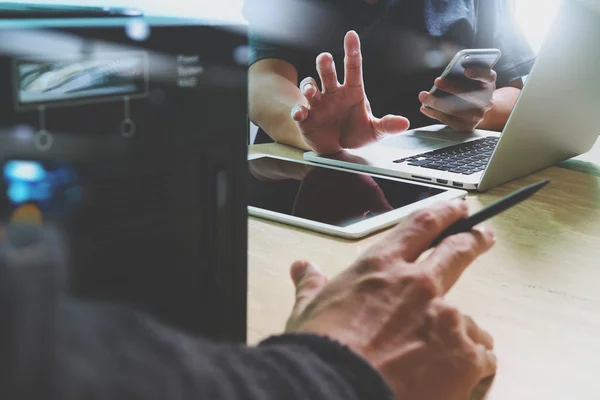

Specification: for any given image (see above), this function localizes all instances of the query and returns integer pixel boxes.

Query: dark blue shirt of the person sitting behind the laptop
[244,0,535,140]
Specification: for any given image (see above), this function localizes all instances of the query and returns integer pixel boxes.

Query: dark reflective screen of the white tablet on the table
[248,157,445,227]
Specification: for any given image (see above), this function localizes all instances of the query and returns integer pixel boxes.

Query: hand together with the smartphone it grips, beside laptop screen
[419,49,501,132]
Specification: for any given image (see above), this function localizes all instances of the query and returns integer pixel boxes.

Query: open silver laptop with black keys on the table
[304,0,600,191]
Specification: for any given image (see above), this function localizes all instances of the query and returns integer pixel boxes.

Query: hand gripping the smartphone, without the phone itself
[419,68,496,132]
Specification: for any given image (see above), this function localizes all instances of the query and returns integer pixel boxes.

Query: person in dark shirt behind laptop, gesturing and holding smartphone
[245,0,535,154]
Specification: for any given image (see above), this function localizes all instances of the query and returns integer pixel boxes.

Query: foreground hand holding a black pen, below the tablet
[287,202,496,400]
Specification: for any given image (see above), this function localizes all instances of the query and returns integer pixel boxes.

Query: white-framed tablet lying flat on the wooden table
[248,154,467,239]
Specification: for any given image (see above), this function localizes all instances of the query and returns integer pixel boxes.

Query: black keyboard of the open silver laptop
[394,136,498,175]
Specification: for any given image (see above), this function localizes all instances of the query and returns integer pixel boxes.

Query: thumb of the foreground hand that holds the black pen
[290,261,328,315]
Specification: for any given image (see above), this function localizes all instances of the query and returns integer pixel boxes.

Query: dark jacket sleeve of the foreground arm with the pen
[0,227,393,400]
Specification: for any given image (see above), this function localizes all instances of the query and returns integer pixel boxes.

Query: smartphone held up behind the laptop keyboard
[429,49,502,97]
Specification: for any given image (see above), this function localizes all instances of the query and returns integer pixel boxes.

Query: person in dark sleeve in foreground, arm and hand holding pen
[0,201,496,400]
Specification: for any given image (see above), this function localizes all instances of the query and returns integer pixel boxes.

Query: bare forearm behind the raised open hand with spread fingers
[249,72,309,150]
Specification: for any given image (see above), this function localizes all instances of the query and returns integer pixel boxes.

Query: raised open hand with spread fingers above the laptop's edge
[292,31,409,154]
